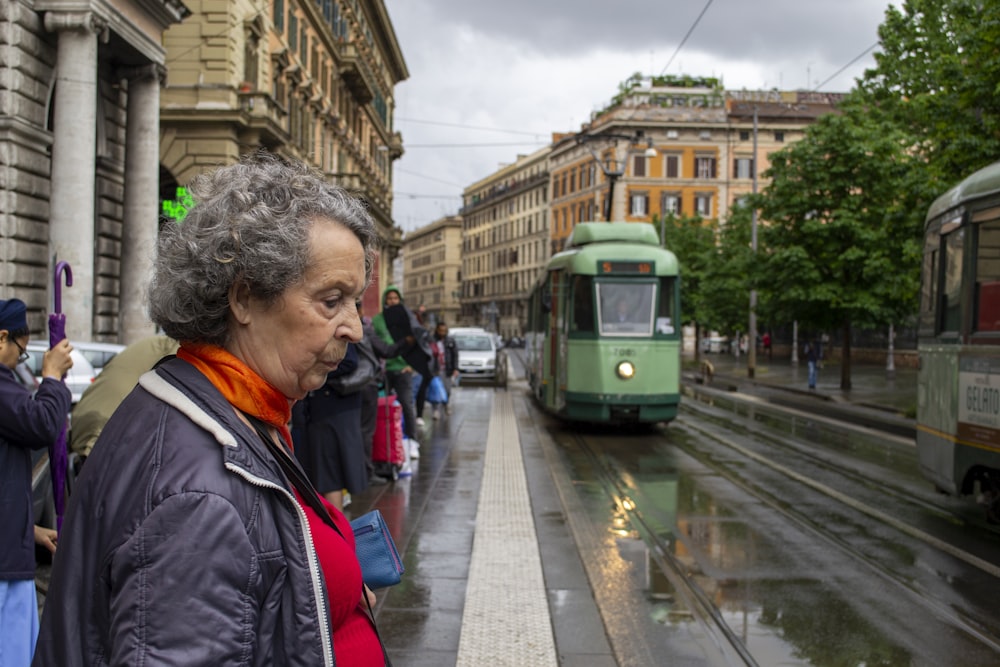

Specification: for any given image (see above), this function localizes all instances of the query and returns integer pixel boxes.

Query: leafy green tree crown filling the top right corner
[857,0,1000,190]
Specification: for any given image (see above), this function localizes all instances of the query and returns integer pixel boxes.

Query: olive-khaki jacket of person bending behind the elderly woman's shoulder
[70,335,178,468]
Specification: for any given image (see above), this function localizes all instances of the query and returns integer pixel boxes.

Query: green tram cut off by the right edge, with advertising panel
[917,162,1000,522]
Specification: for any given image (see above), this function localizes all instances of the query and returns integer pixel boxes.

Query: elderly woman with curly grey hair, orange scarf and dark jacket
[35,156,386,667]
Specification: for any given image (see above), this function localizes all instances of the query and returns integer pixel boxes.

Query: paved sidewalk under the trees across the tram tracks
[682,354,917,416]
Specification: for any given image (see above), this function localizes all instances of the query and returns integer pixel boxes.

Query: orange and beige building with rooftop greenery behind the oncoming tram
[549,77,842,251]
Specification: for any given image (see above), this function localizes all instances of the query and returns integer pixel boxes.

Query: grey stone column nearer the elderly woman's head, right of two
[118,64,166,345]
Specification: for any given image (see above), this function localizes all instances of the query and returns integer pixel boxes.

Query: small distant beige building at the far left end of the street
[400,215,462,327]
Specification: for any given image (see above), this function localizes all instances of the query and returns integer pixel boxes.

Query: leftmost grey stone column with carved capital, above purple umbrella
[45,12,107,340]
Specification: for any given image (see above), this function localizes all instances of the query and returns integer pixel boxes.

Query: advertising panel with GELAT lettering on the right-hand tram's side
[957,356,1000,447]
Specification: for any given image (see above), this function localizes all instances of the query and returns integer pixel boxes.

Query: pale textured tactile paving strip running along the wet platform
[457,392,559,667]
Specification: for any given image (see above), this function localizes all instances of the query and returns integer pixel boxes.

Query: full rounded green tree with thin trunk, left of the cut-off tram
[754,105,921,389]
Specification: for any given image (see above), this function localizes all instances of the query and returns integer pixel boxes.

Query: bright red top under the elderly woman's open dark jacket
[296,493,385,667]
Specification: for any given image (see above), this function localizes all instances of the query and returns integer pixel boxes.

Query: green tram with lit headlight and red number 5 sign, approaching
[525,222,681,423]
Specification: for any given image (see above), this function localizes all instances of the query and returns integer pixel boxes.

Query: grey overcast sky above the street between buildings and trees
[384,0,899,231]
